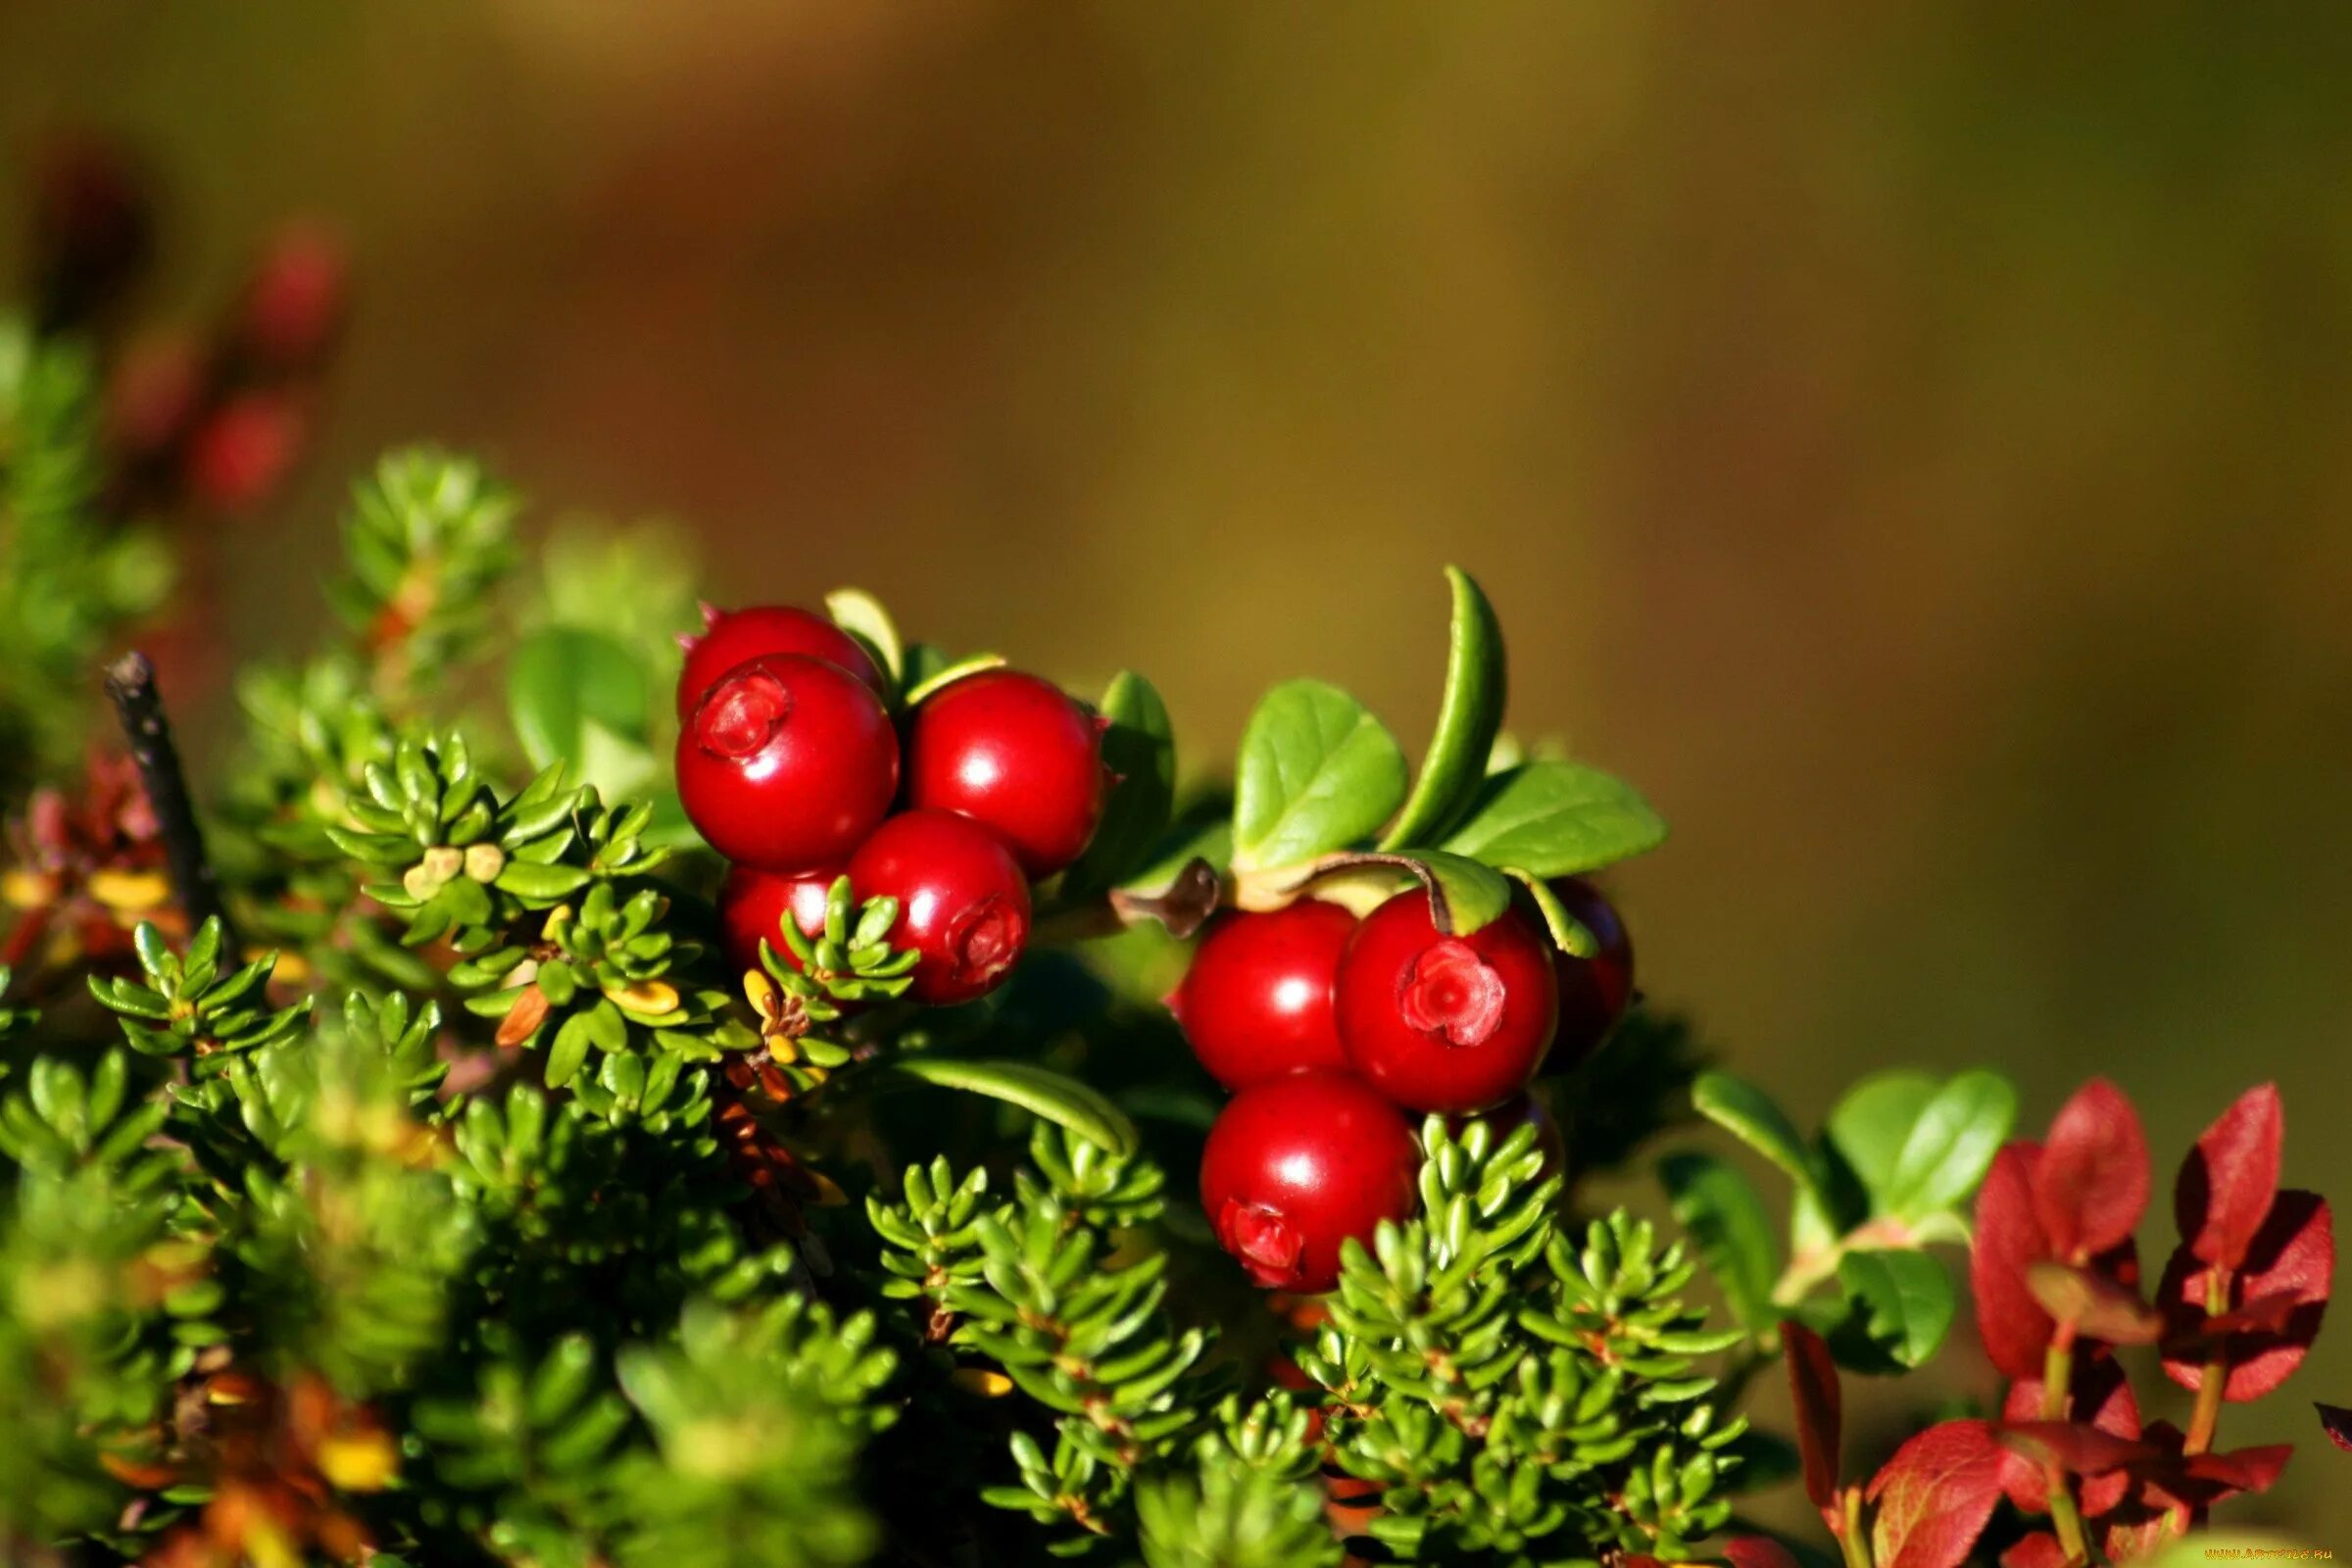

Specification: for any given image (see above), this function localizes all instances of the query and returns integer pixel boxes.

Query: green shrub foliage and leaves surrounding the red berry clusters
[0,313,2314,1568]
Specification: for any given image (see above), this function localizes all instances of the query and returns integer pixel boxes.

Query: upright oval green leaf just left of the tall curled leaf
[1233,679,1404,870]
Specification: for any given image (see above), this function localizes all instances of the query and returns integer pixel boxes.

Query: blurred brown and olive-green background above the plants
[0,0,2352,1546]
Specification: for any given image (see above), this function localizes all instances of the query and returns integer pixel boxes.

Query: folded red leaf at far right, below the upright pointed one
[2157,1190,2335,1403]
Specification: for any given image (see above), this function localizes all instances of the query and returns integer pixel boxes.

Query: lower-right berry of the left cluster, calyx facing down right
[849,811,1030,1006]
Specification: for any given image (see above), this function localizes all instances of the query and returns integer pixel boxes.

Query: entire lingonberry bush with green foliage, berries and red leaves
[0,315,2333,1568]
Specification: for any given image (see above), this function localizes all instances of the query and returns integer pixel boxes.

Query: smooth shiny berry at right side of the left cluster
[906,670,1110,877]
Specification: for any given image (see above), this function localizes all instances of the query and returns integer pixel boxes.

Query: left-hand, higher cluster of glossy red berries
[677,607,1107,1006]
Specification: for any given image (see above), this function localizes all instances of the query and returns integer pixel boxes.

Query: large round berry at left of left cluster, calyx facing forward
[677,654,899,872]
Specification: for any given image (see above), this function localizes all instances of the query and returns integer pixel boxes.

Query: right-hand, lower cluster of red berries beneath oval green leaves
[1169,879,1633,1293]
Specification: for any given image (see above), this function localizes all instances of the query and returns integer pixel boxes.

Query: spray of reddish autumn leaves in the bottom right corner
[1778,1081,2352,1568]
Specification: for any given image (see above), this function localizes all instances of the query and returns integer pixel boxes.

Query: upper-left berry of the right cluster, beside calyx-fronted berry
[1169,898,1354,1089]
